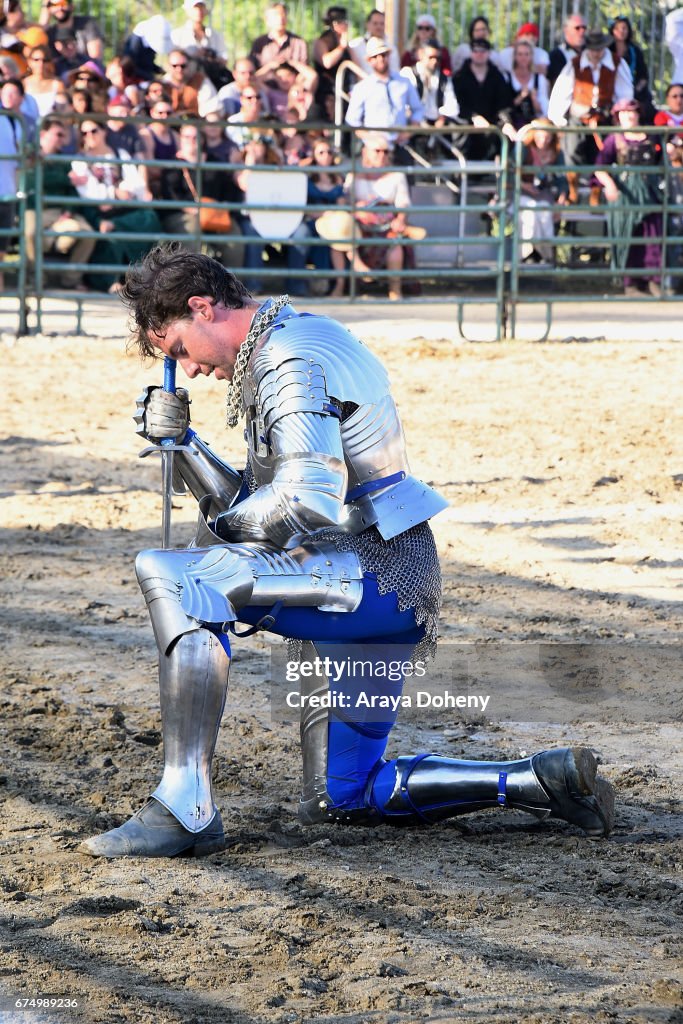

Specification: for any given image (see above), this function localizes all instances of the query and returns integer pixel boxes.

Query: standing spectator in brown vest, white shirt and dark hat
[548,29,633,203]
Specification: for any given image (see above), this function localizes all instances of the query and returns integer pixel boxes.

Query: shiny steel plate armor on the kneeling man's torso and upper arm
[214,306,447,545]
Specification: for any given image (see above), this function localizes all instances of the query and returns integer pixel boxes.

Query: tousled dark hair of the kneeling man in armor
[120,242,252,357]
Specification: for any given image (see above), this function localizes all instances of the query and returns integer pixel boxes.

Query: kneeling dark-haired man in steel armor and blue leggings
[81,244,613,857]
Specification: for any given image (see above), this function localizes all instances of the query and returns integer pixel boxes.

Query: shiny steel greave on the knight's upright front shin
[153,629,230,833]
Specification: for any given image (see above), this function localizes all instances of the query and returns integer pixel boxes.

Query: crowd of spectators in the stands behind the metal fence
[0,0,683,299]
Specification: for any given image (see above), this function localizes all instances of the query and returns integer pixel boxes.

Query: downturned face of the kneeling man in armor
[150,305,244,381]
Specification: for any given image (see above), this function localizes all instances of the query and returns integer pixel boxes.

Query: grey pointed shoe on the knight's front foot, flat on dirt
[78,799,225,857]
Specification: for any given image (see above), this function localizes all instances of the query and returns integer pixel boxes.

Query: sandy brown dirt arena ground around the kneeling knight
[0,311,683,1024]
